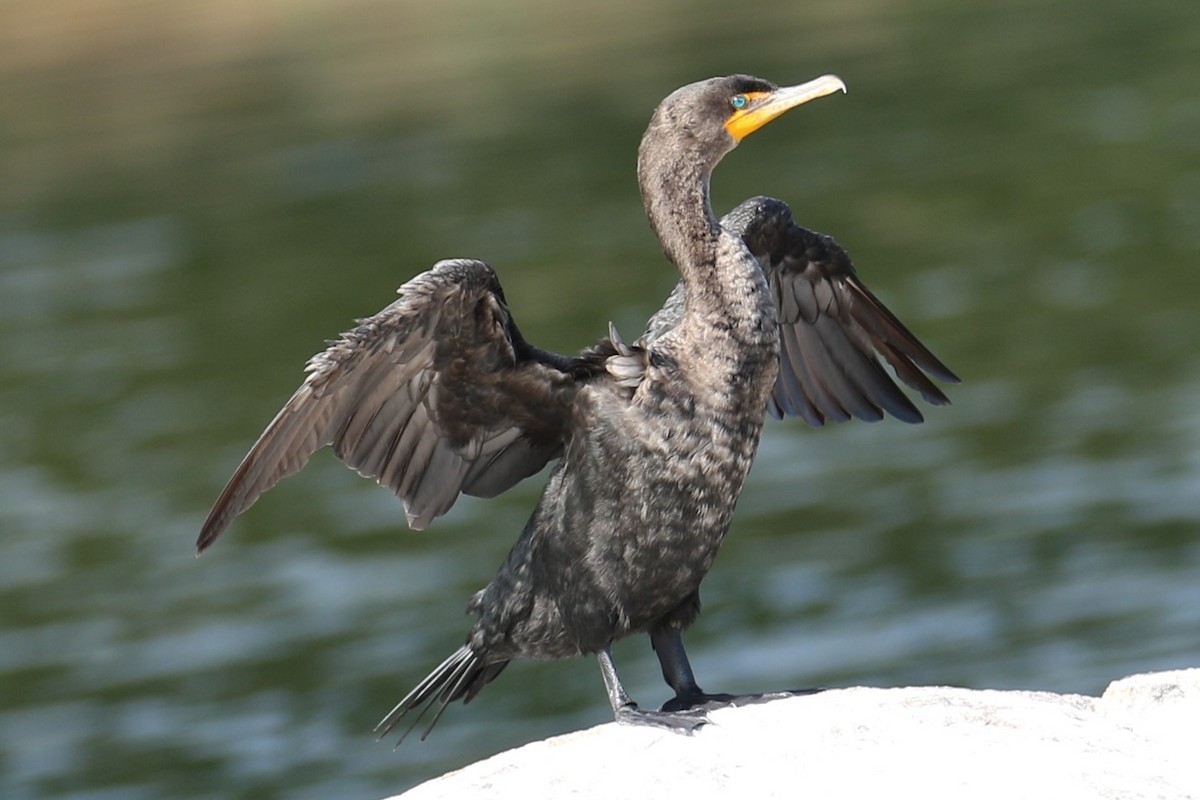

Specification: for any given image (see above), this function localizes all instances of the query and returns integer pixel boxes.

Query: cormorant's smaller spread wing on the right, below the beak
[721,197,959,426]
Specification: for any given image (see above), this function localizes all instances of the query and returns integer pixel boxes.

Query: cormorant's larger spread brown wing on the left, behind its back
[197,260,575,552]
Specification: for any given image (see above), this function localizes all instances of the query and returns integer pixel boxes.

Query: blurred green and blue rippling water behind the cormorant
[0,0,1200,800]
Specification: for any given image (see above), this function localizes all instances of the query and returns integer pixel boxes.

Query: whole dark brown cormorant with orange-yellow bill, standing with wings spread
[197,74,959,740]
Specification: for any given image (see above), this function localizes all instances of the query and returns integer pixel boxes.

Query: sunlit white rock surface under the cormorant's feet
[394,669,1200,800]
